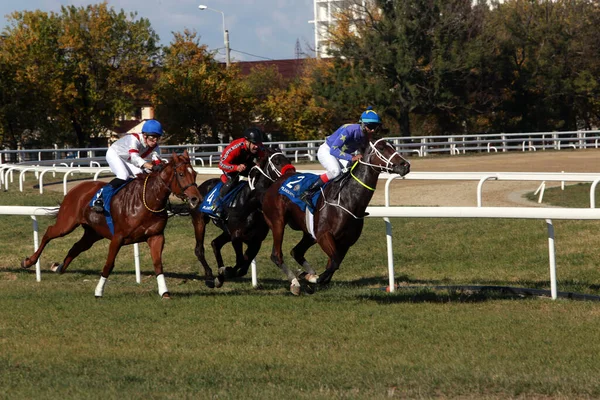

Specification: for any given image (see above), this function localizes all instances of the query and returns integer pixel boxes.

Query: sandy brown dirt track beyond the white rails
[48,150,600,207]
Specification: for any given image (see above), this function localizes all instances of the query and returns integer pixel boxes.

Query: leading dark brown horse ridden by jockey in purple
[263,139,410,295]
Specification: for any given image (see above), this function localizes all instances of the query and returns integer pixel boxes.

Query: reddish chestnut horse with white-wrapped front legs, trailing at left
[21,151,200,298]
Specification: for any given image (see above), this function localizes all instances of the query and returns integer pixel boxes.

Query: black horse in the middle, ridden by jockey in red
[191,148,295,288]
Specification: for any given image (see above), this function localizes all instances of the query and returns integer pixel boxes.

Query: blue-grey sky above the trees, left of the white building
[0,0,315,62]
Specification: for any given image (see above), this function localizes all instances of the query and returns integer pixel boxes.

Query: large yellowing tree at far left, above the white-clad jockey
[3,3,158,147]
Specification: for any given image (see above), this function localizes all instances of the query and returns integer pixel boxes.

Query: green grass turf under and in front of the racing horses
[0,183,600,399]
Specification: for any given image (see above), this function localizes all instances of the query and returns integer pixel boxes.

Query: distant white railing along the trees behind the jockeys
[0,130,600,167]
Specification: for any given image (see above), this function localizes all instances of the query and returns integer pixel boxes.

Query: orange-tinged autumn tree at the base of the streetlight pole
[153,30,252,143]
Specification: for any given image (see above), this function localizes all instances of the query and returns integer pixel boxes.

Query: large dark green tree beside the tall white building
[319,0,481,136]
